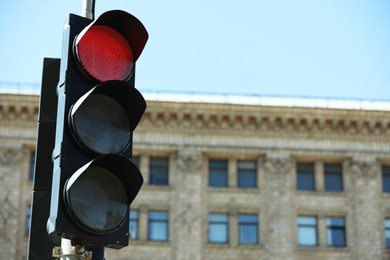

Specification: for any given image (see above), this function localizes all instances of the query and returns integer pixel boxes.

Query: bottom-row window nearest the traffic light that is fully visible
[148,211,168,241]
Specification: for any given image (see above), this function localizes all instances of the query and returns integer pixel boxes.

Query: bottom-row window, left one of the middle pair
[208,214,229,243]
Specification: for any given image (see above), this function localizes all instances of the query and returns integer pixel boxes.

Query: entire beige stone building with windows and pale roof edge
[0,90,390,260]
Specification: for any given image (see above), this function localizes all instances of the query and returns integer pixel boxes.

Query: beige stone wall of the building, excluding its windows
[0,94,390,260]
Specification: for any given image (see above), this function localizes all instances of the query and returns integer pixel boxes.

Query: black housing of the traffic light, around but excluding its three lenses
[47,11,147,249]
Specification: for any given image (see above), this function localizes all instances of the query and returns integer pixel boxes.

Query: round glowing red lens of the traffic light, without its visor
[76,25,134,81]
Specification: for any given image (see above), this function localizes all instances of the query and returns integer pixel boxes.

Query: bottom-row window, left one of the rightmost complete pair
[297,216,318,246]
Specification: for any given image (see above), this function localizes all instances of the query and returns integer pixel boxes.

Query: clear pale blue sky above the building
[0,0,390,101]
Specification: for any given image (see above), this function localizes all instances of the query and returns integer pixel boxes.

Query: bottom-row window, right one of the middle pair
[238,215,259,245]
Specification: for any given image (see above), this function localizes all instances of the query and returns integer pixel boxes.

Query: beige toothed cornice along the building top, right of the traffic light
[139,102,390,140]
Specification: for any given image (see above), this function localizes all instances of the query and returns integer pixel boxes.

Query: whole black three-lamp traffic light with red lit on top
[47,10,148,249]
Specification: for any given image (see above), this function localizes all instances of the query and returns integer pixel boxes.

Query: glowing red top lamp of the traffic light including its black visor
[74,10,148,82]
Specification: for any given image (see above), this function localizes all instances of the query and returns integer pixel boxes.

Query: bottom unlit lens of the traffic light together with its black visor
[64,154,143,233]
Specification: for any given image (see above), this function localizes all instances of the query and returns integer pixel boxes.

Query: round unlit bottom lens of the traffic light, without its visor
[66,167,128,233]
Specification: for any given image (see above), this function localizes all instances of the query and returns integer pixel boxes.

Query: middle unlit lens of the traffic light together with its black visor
[69,80,146,154]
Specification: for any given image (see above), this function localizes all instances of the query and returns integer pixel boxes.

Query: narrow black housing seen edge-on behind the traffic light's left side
[27,58,60,260]
